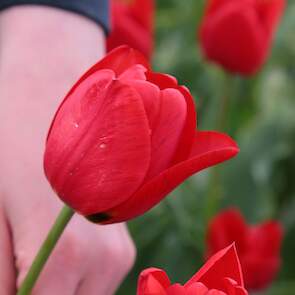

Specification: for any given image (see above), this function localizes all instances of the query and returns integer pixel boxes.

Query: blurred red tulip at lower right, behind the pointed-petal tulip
[207,209,282,290]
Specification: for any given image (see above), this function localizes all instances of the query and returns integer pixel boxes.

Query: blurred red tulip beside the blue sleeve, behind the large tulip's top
[107,0,155,59]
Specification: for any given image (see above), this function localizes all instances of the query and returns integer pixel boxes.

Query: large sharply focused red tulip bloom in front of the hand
[44,46,238,223]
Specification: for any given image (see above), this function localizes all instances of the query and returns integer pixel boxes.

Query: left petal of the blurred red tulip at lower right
[206,208,248,257]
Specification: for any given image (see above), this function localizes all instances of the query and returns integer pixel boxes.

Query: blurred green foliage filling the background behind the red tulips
[117,0,295,295]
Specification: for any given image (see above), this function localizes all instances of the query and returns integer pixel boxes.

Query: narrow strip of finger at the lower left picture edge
[0,202,16,295]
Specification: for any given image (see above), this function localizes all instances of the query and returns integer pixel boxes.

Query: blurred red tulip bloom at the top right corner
[200,0,285,75]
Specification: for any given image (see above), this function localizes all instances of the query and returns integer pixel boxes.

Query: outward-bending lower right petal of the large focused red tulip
[106,131,239,223]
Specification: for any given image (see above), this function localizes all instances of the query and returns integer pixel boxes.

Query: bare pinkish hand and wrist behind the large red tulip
[0,5,135,295]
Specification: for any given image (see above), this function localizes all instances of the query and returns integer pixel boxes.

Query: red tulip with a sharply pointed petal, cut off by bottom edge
[137,245,248,295]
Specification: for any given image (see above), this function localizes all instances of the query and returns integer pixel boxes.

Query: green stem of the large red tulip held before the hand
[16,206,74,295]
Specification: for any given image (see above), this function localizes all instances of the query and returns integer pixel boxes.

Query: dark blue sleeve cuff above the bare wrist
[0,0,110,34]
